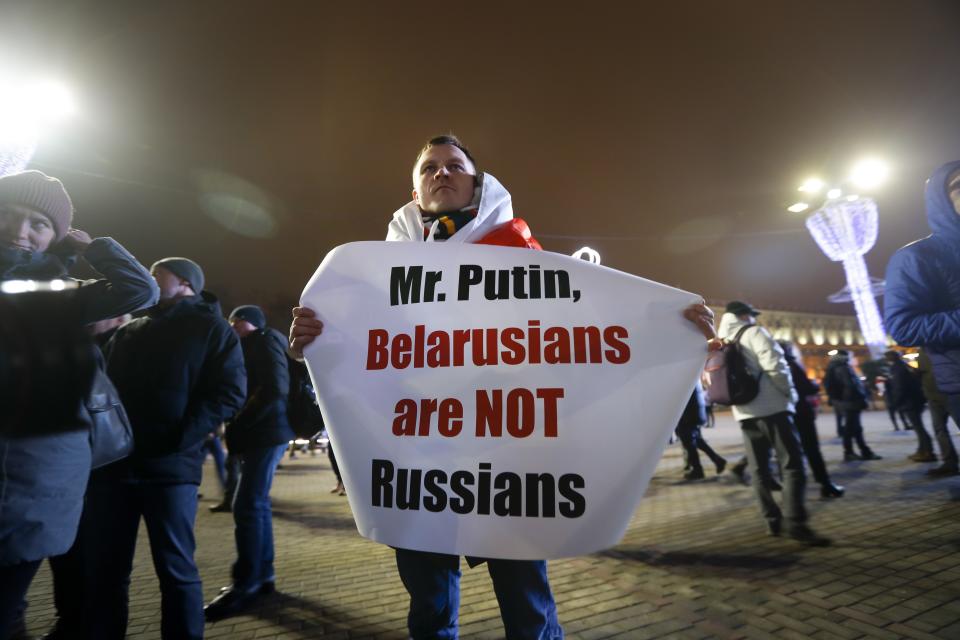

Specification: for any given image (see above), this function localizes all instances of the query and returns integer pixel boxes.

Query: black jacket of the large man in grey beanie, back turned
[93,291,247,484]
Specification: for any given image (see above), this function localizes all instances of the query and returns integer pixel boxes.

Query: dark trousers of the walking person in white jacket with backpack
[740,411,807,531]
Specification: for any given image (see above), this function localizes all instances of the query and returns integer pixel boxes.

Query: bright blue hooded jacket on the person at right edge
[884,161,960,394]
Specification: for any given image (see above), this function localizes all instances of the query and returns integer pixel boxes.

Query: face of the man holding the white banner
[413,144,477,213]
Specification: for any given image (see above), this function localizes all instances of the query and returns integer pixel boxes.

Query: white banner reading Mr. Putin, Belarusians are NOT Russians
[301,242,706,559]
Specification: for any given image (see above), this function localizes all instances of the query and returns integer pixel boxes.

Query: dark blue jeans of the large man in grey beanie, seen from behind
[80,482,204,640]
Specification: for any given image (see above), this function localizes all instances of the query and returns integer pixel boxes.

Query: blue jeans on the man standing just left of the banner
[233,444,287,593]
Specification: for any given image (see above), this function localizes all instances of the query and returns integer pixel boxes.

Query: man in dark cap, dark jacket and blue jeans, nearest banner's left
[205,305,293,620]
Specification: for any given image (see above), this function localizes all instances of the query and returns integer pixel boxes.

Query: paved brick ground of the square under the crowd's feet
[20,412,960,640]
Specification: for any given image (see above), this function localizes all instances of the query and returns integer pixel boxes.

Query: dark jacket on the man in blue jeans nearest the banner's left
[226,327,293,453]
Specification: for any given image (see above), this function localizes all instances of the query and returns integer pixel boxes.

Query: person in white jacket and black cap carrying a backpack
[717,300,830,546]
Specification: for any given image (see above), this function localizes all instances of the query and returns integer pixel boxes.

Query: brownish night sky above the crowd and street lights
[0,0,960,327]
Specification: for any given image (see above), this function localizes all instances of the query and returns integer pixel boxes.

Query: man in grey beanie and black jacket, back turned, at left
[81,257,246,640]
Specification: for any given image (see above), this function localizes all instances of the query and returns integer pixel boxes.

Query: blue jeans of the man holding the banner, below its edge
[396,549,563,640]
